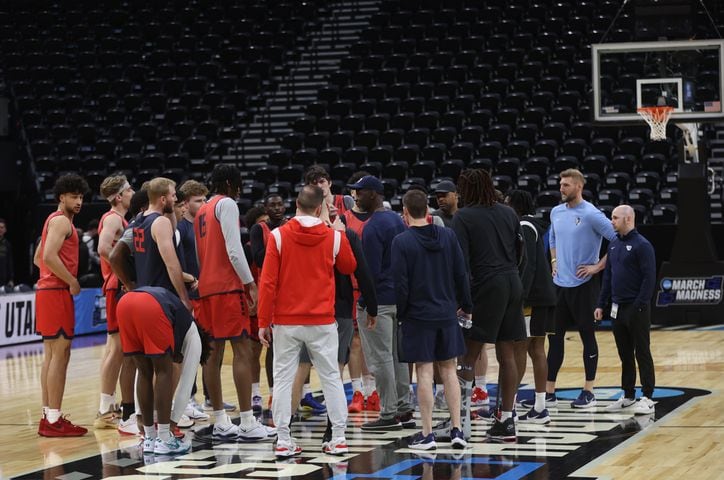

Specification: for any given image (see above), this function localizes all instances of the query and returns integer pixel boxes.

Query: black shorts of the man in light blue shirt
[556,277,600,333]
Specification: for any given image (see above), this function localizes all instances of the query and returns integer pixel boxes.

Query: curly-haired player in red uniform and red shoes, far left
[33,174,88,437]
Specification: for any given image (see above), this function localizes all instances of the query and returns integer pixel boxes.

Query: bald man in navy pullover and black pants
[593,205,656,415]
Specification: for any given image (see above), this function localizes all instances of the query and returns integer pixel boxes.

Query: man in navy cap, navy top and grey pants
[347,175,415,431]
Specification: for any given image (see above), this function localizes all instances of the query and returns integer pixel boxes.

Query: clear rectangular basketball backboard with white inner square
[591,39,724,123]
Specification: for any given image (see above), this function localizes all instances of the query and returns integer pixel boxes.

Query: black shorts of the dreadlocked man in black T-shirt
[464,273,526,343]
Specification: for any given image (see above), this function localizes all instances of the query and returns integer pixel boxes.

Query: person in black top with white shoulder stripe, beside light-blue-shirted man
[505,190,556,424]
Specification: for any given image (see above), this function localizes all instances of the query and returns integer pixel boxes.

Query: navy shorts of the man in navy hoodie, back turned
[397,320,465,363]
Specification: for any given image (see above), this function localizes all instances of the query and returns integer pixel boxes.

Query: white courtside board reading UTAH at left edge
[0,292,40,346]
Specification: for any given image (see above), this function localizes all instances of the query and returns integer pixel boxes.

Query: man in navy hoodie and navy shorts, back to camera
[391,190,472,450]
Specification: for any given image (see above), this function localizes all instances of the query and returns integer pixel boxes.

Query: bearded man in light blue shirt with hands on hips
[546,168,616,408]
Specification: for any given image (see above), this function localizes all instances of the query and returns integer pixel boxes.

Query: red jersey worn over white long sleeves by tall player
[194,195,244,297]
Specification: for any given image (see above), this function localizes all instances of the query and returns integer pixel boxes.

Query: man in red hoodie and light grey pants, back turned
[258,185,357,457]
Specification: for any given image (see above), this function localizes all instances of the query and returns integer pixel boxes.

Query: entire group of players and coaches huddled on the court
[34,164,656,457]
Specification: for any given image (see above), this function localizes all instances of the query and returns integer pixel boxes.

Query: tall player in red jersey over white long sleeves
[194,164,275,441]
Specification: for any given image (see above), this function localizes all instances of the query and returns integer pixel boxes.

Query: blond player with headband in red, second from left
[93,175,139,435]
